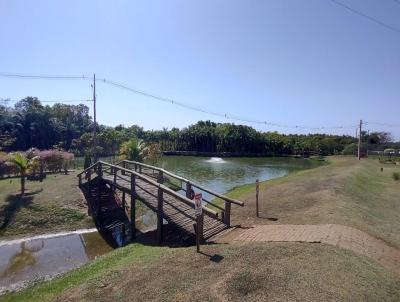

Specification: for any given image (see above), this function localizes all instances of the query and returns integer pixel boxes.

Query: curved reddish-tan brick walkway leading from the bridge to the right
[232,224,400,273]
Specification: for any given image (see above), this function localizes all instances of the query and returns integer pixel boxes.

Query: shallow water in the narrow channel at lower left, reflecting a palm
[0,232,113,294]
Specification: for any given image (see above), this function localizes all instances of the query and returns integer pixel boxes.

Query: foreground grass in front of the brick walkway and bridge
[0,243,400,301]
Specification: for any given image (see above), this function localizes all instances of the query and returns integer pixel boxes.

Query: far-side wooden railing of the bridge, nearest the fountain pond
[117,160,244,226]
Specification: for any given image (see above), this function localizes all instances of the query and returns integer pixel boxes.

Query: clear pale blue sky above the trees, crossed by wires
[0,0,400,139]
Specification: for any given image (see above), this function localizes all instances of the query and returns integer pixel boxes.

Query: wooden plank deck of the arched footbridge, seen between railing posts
[102,171,227,240]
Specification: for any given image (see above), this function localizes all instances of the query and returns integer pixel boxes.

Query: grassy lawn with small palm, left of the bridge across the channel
[0,173,93,239]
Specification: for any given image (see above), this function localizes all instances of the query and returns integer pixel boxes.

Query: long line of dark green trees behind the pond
[0,97,391,156]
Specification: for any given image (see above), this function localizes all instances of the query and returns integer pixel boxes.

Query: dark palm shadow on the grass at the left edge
[0,189,43,231]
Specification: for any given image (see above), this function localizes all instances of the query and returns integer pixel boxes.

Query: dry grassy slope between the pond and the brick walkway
[227,157,400,248]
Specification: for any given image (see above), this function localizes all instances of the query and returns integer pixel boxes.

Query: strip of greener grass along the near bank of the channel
[0,244,171,301]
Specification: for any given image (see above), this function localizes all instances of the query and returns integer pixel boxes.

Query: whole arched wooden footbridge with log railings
[78,160,243,242]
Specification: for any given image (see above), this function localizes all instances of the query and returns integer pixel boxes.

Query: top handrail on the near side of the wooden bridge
[78,161,218,217]
